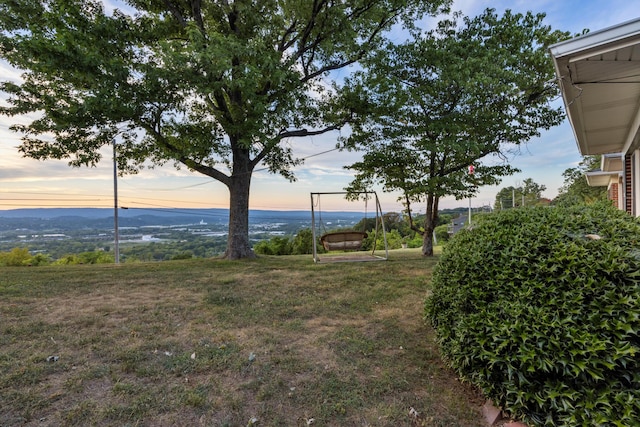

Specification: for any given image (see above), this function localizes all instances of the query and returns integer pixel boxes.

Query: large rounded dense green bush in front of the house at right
[425,203,640,426]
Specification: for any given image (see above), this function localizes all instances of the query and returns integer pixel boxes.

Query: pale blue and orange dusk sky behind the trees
[0,0,640,212]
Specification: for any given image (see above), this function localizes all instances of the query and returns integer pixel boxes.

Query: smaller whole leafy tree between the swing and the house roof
[344,9,569,256]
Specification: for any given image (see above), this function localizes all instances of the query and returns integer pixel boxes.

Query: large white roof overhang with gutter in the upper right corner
[549,18,640,155]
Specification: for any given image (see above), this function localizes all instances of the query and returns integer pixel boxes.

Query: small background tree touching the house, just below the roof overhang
[553,156,607,206]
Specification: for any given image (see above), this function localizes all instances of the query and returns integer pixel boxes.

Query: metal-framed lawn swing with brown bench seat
[311,191,389,263]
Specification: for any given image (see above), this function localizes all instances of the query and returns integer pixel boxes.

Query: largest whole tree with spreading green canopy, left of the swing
[0,0,447,259]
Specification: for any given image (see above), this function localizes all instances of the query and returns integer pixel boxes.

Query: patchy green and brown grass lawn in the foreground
[0,250,485,427]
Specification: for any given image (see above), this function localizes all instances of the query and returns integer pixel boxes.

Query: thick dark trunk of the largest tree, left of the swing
[224,149,256,260]
